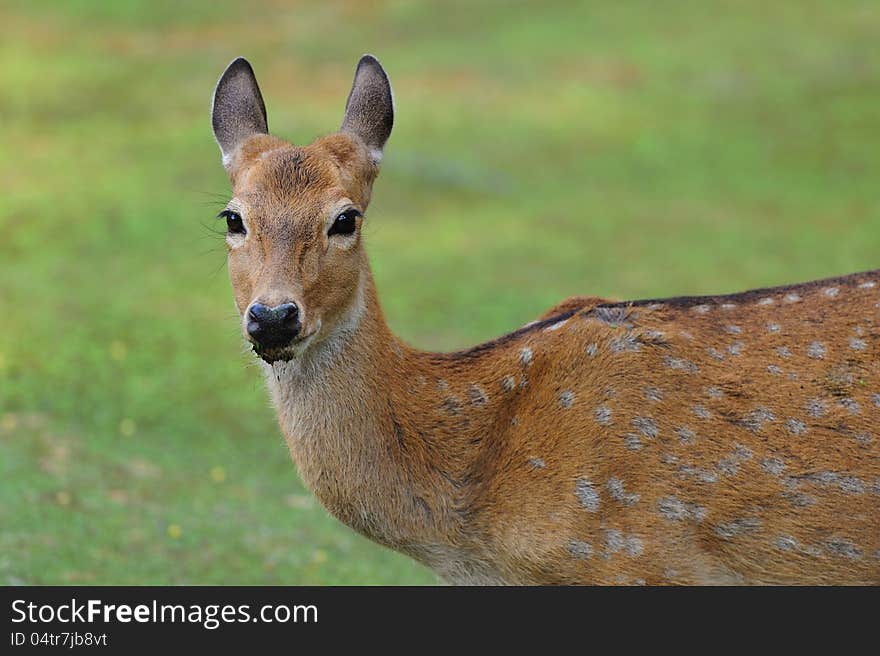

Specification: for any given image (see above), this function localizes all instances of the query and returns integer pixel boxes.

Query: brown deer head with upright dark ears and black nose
[212,55,394,363]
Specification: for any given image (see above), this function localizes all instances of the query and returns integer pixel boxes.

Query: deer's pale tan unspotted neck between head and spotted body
[264,270,470,560]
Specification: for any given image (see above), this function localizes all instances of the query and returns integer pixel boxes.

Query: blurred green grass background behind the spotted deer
[0,0,880,584]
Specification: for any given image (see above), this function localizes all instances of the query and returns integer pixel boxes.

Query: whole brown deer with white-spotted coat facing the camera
[212,55,880,585]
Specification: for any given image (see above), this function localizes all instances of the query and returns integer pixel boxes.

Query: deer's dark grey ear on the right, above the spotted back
[339,55,394,163]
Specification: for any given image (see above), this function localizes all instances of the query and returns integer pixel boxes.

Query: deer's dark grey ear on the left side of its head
[211,57,269,167]
